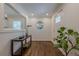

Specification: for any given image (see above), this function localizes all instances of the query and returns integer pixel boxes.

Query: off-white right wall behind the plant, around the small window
[52,3,79,55]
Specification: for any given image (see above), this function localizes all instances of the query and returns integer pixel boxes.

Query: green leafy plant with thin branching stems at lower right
[55,27,79,56]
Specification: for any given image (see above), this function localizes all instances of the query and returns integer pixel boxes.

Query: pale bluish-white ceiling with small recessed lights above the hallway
[17,3,59,17]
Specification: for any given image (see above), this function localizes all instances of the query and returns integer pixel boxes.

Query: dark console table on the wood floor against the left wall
[11,35,32,56]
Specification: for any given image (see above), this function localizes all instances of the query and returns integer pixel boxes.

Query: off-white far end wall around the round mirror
[27,17,52,41]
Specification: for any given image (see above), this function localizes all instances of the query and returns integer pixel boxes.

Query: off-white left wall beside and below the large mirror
[0,4,25,56]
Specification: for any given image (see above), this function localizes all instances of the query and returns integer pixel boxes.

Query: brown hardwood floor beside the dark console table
[24,41,63,56]
